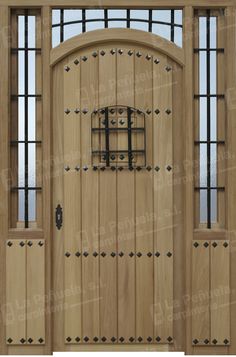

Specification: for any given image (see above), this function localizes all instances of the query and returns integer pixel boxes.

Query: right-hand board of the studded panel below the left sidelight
[27,239,45,345]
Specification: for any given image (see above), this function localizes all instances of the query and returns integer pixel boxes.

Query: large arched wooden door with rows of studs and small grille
[53,30,183,350]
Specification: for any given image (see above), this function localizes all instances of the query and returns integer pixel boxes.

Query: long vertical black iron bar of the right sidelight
[206,10,211,229]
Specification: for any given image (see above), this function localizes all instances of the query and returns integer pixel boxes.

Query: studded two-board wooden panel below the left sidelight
[6,239,45,345]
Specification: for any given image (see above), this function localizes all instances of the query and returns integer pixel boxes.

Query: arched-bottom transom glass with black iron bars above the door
[52,9,183,47]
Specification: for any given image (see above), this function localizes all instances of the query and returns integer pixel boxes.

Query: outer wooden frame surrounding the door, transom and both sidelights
[0,0,236,354]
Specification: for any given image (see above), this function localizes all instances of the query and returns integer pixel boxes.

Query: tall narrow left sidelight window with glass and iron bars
[10,9,42,228]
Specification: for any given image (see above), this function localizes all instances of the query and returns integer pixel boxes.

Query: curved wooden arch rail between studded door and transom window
[50,28,184,66]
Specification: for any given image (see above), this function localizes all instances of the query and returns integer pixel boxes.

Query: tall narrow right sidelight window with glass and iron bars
[194,10,225,229]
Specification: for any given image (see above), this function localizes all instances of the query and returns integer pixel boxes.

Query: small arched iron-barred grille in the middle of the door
[92,106,146,169]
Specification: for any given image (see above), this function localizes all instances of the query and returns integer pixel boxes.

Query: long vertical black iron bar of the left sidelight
[24,10,29,228]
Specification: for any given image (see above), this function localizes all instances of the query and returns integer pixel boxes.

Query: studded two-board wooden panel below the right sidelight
[191,240,230,347]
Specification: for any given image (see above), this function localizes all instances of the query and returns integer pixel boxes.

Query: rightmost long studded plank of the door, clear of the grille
[153,55,173,343]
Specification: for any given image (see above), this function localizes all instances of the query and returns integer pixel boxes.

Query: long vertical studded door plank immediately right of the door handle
[63,56,82,343]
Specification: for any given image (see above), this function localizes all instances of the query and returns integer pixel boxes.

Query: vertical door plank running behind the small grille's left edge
[80,52,99,343]
